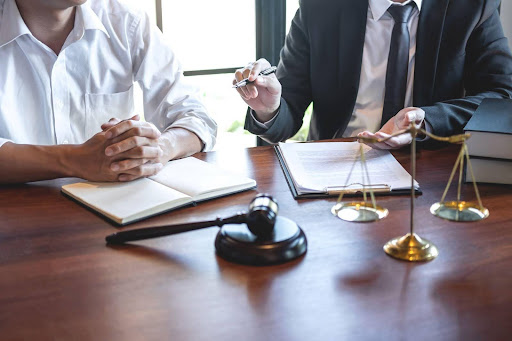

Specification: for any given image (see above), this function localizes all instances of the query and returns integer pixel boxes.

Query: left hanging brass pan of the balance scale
[331,201,389,223]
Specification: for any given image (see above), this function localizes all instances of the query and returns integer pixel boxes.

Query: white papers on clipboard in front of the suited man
[275,142,419,198]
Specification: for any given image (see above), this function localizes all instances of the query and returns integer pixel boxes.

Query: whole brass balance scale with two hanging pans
[331,124,489,262]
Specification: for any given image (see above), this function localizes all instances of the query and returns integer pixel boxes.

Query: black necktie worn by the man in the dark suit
[380,2,414,127]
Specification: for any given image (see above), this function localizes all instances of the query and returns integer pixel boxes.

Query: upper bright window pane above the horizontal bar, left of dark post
[162,0,256,71]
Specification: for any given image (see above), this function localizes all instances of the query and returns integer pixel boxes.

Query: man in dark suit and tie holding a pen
[234,0,512,148]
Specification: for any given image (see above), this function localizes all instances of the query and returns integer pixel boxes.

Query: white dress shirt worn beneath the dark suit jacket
[250,0,422,137]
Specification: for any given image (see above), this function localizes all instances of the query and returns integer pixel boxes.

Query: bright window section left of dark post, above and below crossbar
[162,0,256,149]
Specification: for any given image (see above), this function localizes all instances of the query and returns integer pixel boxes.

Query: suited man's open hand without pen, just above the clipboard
[357,107,425,149]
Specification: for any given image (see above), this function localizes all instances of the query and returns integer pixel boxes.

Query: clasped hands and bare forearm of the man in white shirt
[0,113,162,184]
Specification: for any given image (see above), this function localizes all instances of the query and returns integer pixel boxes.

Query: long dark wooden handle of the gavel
[105,213,246,244]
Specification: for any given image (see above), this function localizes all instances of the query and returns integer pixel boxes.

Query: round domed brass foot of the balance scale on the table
[383,233,439,262]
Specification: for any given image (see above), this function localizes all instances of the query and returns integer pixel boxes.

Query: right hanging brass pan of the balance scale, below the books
[430,201,489,221]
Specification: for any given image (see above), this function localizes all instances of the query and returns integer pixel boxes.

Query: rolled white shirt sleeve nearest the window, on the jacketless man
[129,11,217,151]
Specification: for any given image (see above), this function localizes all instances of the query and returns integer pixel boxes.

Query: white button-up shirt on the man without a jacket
[0,0,217,150]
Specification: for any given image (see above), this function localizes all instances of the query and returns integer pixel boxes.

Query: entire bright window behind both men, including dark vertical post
[121,0,309,149]
